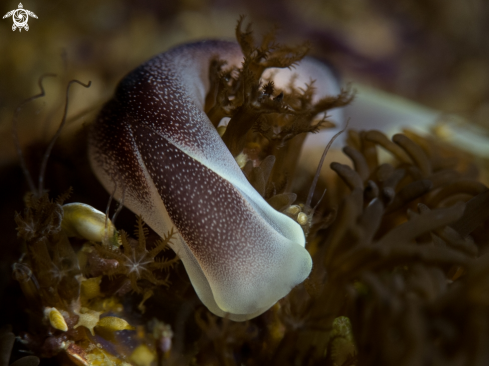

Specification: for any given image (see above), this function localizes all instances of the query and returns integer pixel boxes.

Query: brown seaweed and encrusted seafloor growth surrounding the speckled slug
[6,16,489,366]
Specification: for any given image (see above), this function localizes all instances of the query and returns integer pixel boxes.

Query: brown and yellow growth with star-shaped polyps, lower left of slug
[11,191,179,365]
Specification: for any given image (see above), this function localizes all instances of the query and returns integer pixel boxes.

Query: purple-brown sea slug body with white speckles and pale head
[89,41,339,321]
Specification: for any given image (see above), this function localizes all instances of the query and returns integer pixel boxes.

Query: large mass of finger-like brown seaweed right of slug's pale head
[191,131,489,366]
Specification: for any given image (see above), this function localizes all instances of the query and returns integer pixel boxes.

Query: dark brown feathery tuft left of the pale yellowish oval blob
[13,191,80,307]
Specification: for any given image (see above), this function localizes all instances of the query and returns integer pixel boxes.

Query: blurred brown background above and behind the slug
[0,0,489,161]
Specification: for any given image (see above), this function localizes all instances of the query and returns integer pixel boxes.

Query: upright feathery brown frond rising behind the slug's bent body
[204,17,354,209]
